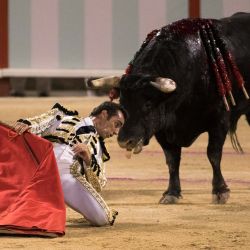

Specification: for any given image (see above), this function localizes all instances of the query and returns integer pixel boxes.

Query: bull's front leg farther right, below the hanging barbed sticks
[207,130,230,204]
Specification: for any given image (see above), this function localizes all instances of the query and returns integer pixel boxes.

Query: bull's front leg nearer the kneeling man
[159,142,181,204]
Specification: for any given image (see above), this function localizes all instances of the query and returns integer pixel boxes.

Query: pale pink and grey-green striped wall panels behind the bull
[9,0,250,73]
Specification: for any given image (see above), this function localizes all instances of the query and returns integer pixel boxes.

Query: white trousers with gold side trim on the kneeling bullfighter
[53,143,110,226]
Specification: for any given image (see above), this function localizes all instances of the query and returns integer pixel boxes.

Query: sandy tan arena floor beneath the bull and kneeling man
[0,97,250,250]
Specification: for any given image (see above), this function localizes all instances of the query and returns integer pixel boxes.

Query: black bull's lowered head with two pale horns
[91,74,176,154]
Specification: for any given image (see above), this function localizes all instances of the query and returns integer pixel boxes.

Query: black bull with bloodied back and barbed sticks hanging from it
[94,13,250,203]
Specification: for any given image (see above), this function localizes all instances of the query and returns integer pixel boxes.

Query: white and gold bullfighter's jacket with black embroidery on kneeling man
[18,103,110,192]
